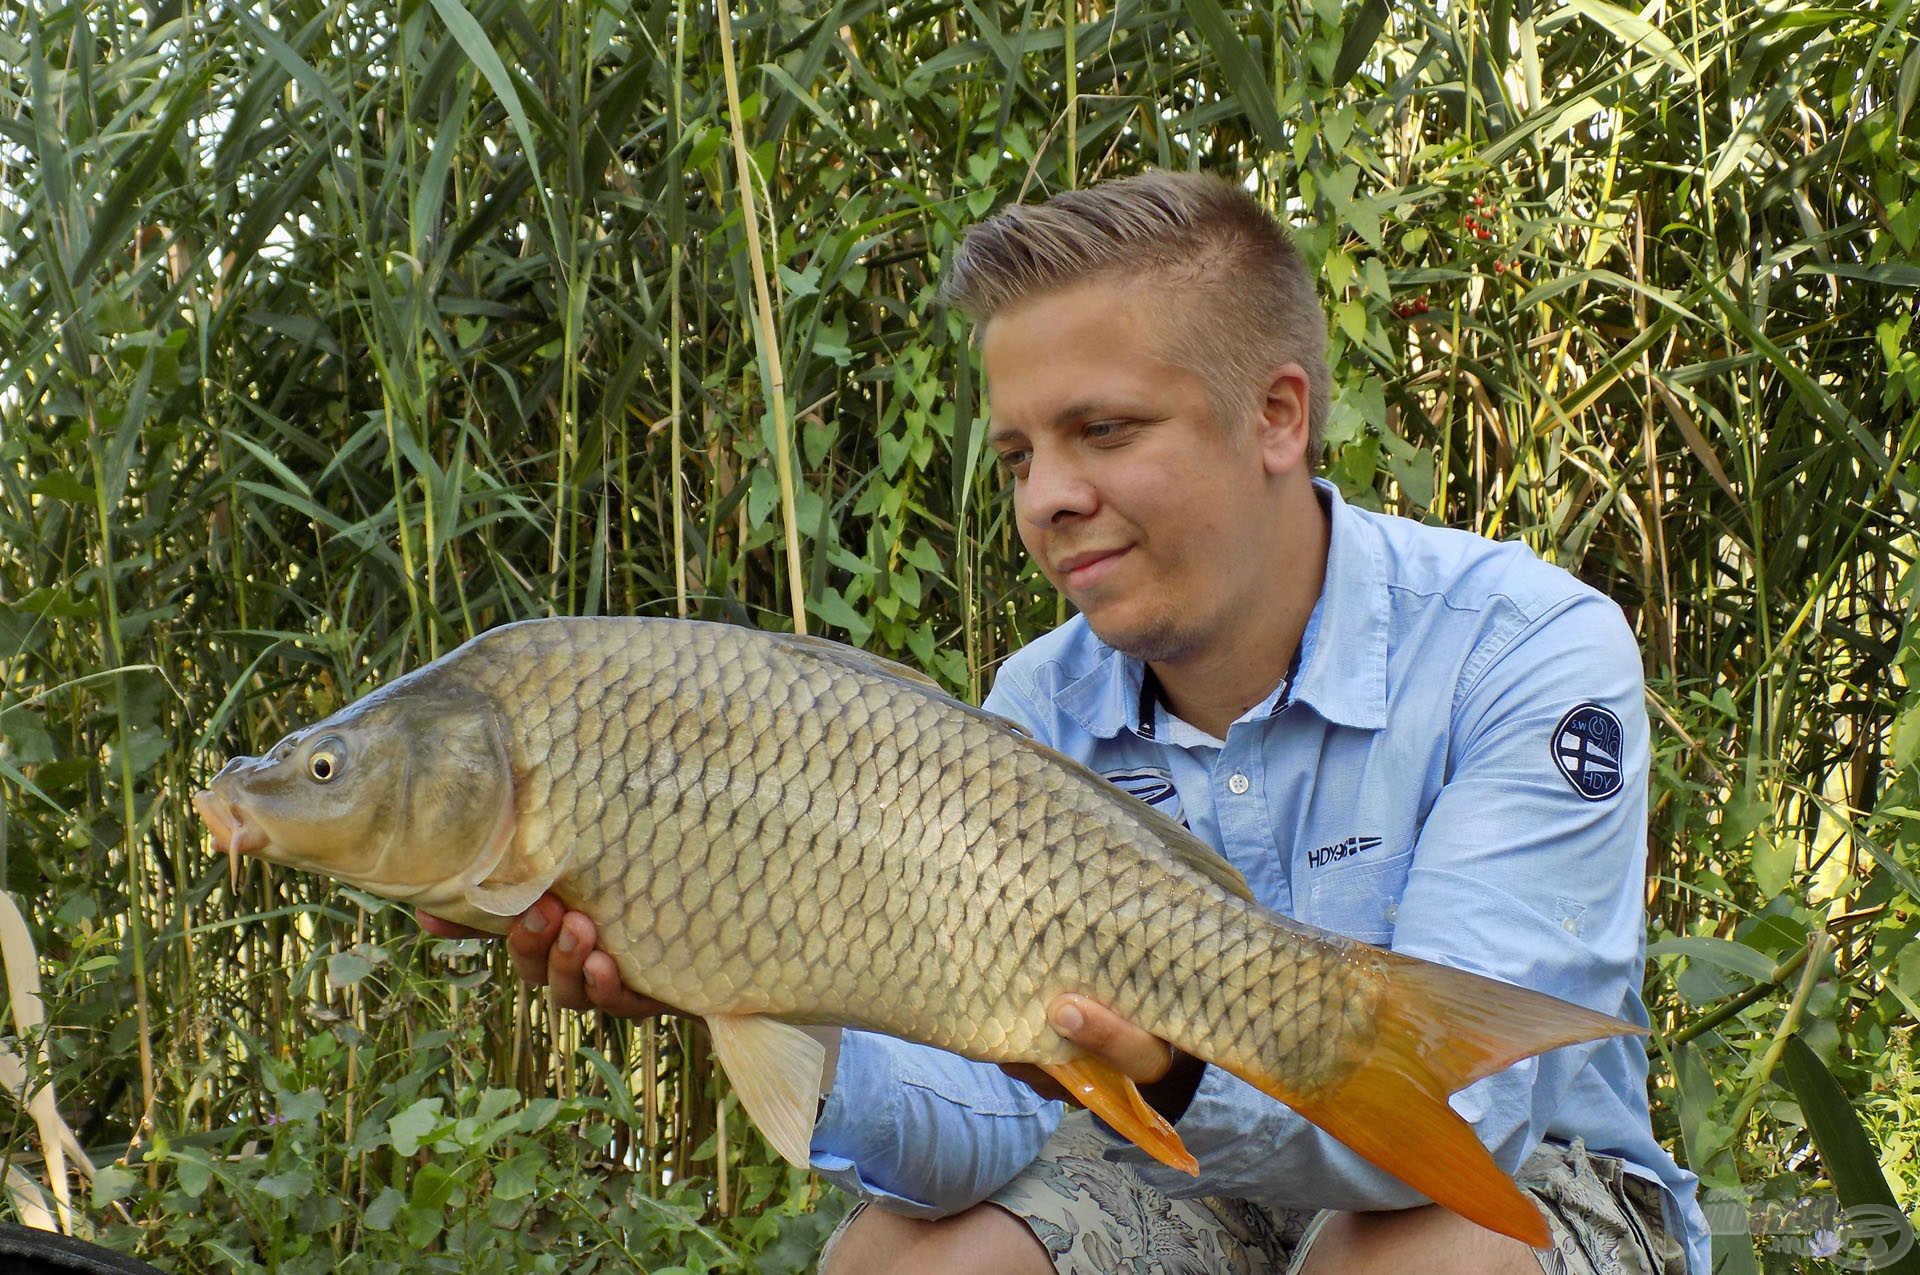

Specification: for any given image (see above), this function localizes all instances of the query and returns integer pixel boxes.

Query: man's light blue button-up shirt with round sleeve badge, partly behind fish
[812,482,1709,1273]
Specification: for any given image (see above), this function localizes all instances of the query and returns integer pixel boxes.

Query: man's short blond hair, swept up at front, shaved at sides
[941,169,1331,457]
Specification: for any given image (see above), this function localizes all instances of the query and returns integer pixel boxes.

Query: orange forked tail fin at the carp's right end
[1221,954,1642,1248]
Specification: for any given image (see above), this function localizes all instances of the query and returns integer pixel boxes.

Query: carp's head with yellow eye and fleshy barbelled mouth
[194,678,530,927]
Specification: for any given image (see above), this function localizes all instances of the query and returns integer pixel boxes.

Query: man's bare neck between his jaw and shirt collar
[1154,488,1329,739]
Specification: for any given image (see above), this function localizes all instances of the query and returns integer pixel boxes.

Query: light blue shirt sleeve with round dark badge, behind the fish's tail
[1108,595,1649,1210]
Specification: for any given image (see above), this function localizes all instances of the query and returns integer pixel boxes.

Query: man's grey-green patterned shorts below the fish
[822,1112,1686,1275]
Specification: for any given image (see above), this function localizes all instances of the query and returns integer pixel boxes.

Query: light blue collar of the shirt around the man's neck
[1054,478,1386,739]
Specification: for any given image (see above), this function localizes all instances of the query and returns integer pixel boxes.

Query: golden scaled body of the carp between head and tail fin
[474,620,1377,1087]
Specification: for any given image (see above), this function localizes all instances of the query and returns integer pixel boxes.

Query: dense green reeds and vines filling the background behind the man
[0,0,1920,1271]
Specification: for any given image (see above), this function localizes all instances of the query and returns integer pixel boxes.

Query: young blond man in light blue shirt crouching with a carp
[420,173,1705,1275]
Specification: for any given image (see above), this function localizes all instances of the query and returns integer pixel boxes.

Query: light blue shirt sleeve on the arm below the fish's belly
[812,678,1062,1217]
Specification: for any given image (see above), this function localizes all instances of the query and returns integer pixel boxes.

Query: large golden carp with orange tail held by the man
[194,618,1642,1246]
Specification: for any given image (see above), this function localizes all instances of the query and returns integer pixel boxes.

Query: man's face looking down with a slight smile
[981,282,1271,661]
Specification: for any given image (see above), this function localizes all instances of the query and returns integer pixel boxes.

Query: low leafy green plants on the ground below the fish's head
[92,956,835,1271]
